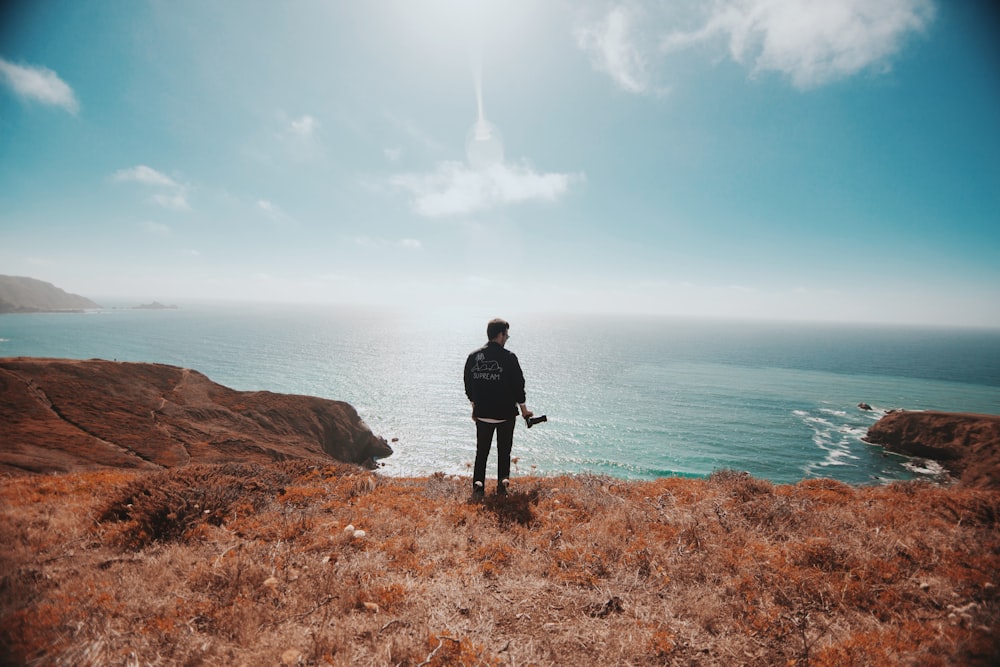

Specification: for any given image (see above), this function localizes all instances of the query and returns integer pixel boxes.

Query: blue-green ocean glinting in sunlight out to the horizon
[0,305,1000,484]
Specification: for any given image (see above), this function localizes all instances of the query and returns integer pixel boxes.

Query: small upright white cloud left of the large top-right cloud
[574,5,649,93]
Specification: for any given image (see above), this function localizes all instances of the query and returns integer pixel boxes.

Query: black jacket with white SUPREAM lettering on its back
[465,341,525,419]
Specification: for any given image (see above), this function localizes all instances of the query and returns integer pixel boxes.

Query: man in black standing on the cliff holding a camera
[465,319,534,499]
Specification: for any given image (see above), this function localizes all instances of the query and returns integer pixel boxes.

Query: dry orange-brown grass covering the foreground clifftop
[0,462,1000,667]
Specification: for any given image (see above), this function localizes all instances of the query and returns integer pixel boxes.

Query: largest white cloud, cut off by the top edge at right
[662,0,934,88]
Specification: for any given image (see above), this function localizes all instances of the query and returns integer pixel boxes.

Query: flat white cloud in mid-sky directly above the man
[389,162,584,218]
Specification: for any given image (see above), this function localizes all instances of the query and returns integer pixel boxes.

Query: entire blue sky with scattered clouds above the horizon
[0,0,1000,327]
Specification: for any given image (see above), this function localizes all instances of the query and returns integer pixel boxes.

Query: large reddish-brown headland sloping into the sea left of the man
[0,357,392,473]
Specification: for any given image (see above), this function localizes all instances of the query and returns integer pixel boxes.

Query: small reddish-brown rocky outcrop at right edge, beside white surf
[865,410,1000,489]
